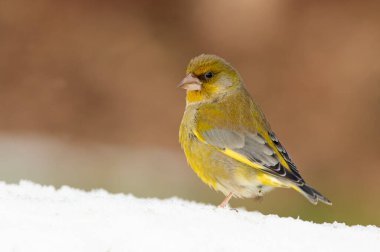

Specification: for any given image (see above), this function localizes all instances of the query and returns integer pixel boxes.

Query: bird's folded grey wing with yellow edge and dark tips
[194,129,304,185]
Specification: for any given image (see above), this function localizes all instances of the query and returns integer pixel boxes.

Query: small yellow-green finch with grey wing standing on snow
[178,54,331,207]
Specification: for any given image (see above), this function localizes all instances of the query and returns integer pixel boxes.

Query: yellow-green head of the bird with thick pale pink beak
[178,54,242,103]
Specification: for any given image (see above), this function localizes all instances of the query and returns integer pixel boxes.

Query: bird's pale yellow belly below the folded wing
[183,139,270,198]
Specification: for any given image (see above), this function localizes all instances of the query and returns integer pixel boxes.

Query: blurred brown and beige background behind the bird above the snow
[0,0,380,225]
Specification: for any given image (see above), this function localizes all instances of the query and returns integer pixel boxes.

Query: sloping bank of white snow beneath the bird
[0,181,380,252]
